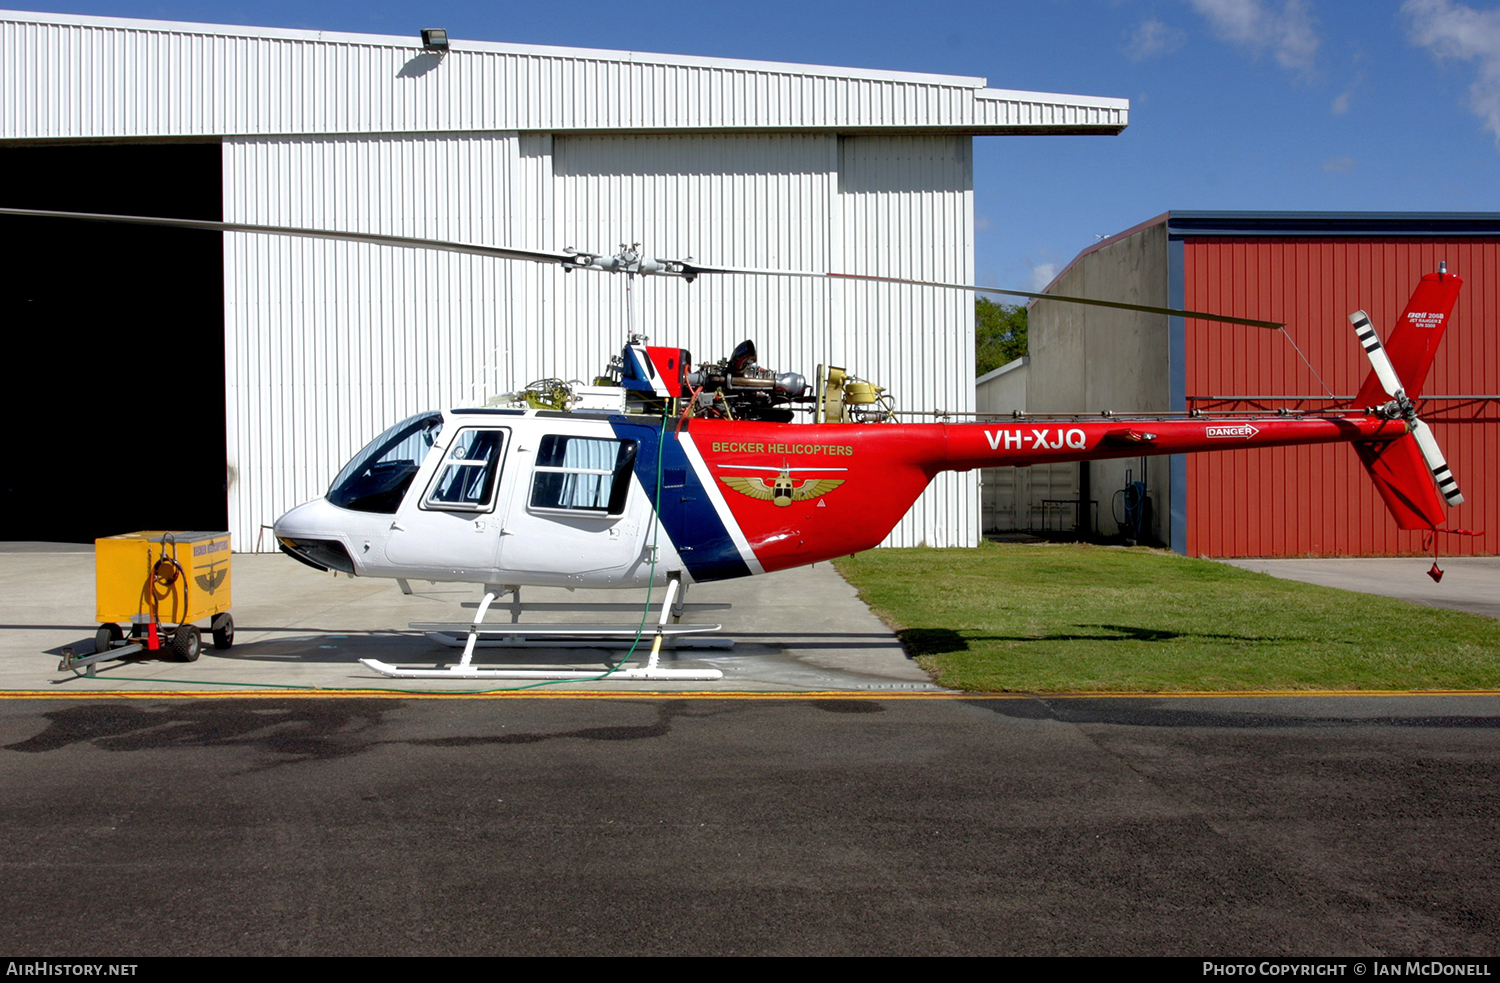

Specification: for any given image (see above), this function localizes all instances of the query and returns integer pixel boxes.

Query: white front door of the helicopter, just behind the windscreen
[386,426,510,581]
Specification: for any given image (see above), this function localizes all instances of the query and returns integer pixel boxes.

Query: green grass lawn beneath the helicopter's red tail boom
[836,543,1500,692]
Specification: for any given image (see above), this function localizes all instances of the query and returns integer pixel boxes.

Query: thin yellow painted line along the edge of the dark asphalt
[0,689,1500,699]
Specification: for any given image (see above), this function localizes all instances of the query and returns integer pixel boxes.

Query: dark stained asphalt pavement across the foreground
[0,693,1500,957]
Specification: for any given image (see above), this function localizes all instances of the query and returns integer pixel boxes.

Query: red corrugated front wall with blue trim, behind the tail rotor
[1034,212,1500,557]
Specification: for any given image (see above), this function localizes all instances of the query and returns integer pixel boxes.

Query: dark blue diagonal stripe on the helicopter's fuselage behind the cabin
[609,417,750,581]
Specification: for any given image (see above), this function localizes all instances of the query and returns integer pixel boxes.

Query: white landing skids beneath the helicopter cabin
[360,576,734,681]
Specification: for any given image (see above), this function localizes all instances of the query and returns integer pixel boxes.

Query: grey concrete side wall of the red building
[1026,224,1172,543]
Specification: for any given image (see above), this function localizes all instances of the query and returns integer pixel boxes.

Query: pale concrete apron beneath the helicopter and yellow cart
[0,545,939,695]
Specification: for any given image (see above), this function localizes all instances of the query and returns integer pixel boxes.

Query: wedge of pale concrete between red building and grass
[1224,557,1500,618]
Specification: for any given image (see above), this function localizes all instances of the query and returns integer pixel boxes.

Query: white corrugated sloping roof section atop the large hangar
[0,11,1130,140]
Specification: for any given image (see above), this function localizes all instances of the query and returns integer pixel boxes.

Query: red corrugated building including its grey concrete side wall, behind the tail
[980,212,1500,557]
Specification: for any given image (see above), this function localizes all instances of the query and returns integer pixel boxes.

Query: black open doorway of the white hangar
[0,143,227,542]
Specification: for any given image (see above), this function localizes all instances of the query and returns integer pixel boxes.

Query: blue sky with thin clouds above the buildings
[17,0,1500,290]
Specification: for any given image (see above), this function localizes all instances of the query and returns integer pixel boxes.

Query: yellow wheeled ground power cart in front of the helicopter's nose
[95,530,234,662]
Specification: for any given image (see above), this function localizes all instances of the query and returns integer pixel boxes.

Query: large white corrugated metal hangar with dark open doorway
[0,7,1128,549]
